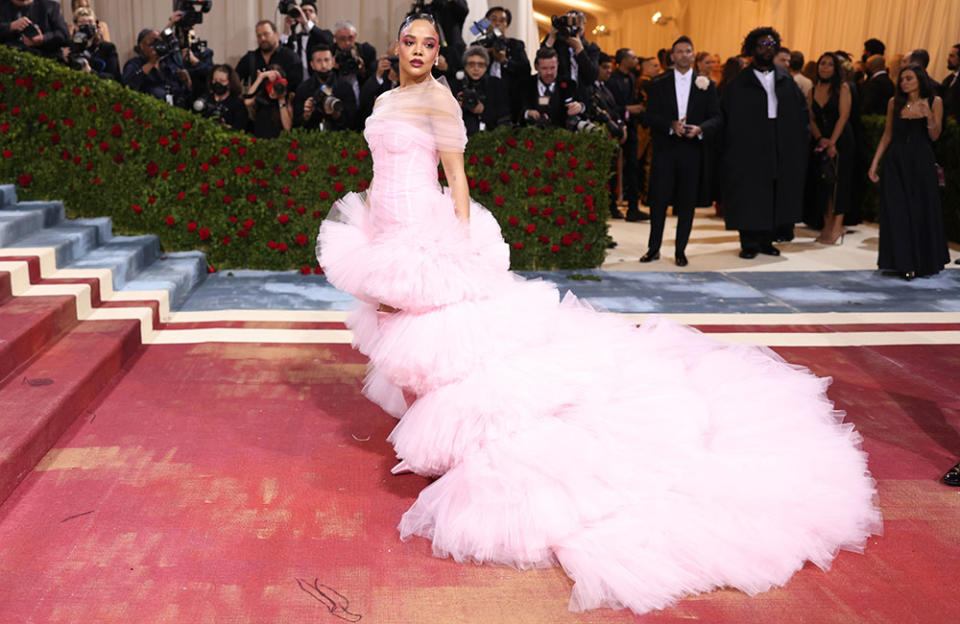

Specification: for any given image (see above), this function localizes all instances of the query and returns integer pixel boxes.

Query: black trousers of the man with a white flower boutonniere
[647,139,703,254]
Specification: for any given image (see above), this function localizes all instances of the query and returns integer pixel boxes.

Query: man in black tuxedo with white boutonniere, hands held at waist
[640,36,720,266]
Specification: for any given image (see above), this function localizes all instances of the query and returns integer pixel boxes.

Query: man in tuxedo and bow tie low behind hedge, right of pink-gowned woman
[522,48,586,128]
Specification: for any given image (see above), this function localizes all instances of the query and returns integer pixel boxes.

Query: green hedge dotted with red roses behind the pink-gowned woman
[0,46,615,272]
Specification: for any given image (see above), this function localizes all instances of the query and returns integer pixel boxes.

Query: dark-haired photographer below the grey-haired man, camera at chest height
[293,44,357,130]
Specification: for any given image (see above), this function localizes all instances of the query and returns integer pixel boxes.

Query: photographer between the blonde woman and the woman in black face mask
[122,28,192,108]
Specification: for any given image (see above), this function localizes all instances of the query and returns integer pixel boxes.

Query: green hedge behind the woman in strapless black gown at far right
[860,115,960,242]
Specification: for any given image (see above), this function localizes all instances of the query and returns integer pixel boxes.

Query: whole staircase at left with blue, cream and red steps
[0,185,207,503]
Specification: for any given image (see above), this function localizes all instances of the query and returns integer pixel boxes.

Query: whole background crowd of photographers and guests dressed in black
[0,0,960,278]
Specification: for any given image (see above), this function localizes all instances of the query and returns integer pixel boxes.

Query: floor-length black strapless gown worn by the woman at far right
[877,116,950,276]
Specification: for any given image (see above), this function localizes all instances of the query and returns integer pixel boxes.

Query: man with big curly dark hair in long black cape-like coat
[720,27,810,259]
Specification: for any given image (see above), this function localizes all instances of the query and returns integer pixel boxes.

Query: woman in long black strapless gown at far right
[868,65,950,280]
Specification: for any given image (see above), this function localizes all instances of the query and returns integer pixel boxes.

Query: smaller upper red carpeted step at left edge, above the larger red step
[0,294,77,383]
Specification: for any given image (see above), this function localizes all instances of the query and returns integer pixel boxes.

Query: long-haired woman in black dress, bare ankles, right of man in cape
[808,52,857,245]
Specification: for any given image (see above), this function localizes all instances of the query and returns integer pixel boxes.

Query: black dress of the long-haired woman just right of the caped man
[804,95,857,229]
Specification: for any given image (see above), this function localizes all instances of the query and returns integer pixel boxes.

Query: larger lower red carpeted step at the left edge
[0,320,140,502]
